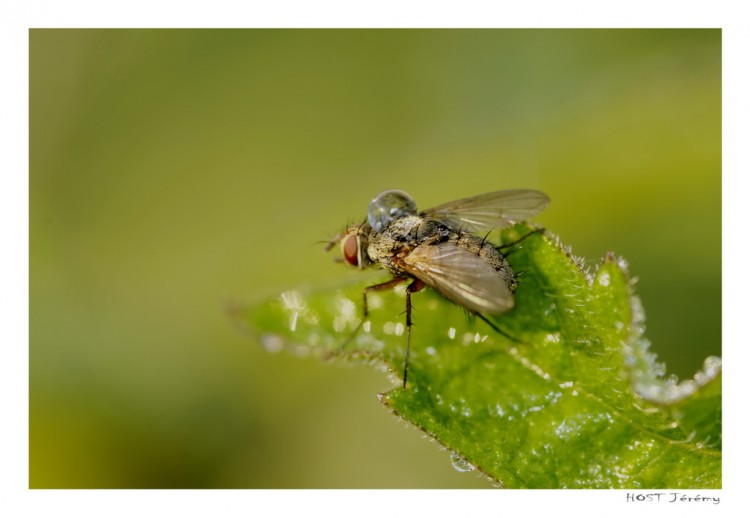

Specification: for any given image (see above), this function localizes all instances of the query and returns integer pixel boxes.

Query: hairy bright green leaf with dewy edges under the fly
[232,225,721,488]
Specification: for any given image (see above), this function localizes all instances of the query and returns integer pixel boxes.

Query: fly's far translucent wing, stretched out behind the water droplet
[422,189,550,232]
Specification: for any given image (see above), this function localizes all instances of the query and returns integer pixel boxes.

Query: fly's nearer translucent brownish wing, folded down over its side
[402,243,513,314]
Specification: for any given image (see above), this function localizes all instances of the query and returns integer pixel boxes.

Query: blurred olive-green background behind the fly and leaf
[30,30,721,488]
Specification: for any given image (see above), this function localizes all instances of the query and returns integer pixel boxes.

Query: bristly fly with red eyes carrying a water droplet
[326,189,550,388]
